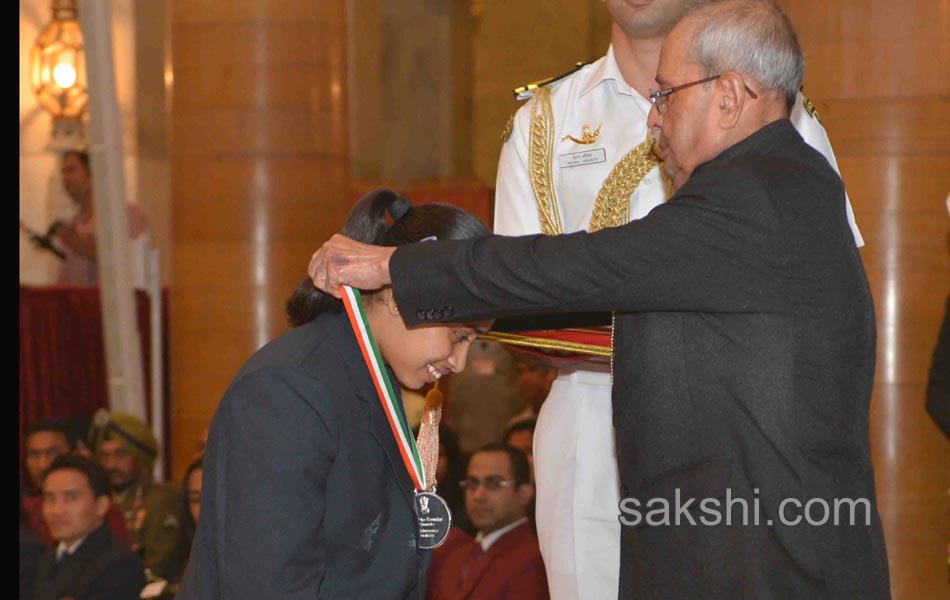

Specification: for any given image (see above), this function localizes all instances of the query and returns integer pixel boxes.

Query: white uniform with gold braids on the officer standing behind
[494,47,864,600]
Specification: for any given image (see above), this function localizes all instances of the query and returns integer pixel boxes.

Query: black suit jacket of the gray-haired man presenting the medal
[390,119,890,600]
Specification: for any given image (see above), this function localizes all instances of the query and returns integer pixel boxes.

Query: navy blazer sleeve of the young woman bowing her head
[196,367,337,600]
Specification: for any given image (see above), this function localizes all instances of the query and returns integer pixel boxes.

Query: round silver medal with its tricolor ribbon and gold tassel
[340,285,452,550]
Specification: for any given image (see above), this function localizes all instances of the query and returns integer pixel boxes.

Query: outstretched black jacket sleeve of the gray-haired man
[390,168,792,324]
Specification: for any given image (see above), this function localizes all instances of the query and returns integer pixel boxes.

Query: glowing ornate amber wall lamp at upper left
[30,0,89,150]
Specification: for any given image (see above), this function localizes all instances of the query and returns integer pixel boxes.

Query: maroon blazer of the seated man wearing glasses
[428,523,550,600]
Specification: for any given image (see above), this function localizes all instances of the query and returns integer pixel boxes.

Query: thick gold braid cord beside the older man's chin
[587,135,660,232]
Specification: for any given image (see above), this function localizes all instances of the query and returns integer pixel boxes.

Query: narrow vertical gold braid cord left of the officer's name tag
[528,87,561,235]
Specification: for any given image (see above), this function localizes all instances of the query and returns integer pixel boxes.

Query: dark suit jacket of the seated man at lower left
[30,525,145,600]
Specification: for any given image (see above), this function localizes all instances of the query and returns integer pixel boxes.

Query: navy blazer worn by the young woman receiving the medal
[177,312,431,600]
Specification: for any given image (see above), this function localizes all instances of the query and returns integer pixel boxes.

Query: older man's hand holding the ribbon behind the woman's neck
[307,234,396,298]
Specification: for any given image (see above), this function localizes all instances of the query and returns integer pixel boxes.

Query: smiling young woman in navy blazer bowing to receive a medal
[177,190,490,600]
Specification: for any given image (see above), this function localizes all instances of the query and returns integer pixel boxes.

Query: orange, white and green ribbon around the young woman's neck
[340,285,426,492]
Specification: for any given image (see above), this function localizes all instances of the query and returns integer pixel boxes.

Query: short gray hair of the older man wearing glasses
[683,0,805,107]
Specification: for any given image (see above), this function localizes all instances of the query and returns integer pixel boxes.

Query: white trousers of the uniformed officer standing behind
[534,370,620,600]
